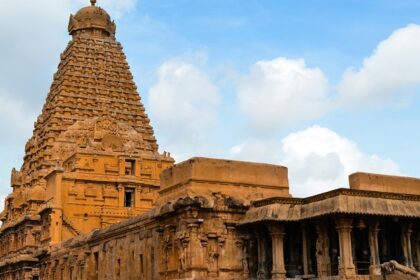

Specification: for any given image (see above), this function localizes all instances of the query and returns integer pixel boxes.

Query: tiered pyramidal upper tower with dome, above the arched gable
[22,1,158,180]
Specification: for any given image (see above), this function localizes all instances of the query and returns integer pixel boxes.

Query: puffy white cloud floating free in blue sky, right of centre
[237,57,330,131]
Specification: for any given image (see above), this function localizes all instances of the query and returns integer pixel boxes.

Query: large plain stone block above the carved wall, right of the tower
[159,157,290,203]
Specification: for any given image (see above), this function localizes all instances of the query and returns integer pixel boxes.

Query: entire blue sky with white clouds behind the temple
[0,0,420,206]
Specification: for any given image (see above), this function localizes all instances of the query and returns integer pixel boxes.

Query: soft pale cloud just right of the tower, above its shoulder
[149,59,220,160]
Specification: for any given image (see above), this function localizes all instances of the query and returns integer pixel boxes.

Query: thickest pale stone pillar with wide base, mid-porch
[335,217,356,277]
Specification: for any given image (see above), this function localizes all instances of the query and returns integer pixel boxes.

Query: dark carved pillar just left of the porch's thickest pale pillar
[315,221,331,278]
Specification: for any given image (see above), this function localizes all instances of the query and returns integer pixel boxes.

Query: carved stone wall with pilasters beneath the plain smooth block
[40,195,246,280]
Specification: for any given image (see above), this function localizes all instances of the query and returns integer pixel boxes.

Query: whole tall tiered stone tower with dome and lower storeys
[0,0,174,266]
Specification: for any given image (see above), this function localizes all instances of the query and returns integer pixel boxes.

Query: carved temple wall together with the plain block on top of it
[35,158,288,280]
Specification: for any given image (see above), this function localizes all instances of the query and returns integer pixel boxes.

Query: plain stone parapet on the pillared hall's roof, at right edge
[349,172,420,195]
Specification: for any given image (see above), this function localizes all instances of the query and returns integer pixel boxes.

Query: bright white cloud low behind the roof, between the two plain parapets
[230,126,400,197]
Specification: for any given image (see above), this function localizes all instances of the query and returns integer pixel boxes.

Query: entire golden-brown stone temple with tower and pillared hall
[0,0,420,280]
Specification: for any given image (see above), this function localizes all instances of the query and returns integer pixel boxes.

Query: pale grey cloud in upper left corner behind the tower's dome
[0,0,136,108]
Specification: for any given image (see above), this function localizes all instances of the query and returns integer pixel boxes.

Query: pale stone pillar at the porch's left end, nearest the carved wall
[268,224,286,280]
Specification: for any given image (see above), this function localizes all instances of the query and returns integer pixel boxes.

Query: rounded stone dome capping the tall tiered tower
[68,5,115,36]
